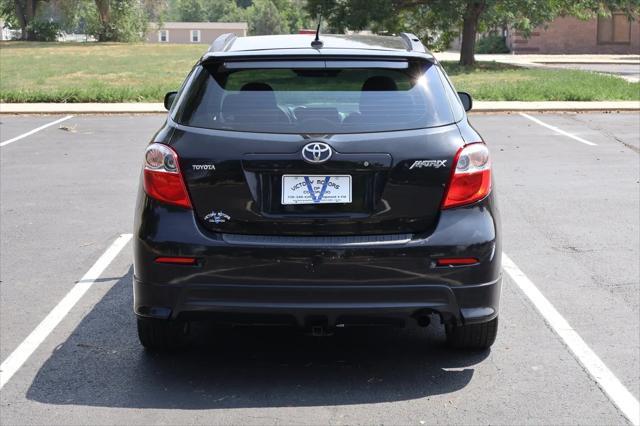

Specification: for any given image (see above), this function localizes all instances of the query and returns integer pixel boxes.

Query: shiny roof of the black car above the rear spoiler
[203,33,433,59]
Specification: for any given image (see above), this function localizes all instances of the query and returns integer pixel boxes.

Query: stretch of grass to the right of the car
[443,62,640,101]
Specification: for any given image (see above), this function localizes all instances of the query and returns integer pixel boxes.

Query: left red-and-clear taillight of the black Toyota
[144,143,191,209]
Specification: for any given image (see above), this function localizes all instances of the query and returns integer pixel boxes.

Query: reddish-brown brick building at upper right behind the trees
[506,13,640,54]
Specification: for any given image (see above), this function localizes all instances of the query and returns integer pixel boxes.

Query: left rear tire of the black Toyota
[137,317,189,352]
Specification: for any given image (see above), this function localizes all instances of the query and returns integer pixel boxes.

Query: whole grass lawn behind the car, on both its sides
[0,42,640,102]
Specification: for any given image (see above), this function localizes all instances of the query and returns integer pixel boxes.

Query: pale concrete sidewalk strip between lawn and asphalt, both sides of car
[0,101,640,114]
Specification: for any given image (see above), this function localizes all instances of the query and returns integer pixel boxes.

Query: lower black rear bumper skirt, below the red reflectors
[134,278,502,327]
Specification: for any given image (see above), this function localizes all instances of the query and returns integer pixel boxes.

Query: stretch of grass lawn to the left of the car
[0,42,207,102]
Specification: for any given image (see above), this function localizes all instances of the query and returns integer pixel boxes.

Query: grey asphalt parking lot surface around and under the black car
[0,113,640,425]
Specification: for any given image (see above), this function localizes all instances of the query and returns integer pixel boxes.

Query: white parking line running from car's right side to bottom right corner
[502,252,640,426]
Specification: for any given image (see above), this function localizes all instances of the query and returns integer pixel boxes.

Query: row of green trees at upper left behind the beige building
[0,0,310,41]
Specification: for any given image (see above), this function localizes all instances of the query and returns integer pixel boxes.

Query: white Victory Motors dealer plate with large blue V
[280,174,353,205]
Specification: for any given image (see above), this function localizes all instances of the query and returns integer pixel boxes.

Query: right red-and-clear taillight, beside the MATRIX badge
[442,143,491,209]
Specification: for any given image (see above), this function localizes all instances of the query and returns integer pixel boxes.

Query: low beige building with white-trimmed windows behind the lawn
[145,22,247,44]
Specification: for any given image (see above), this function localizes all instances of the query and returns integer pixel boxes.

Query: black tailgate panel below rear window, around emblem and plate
[170,121,462,235]
